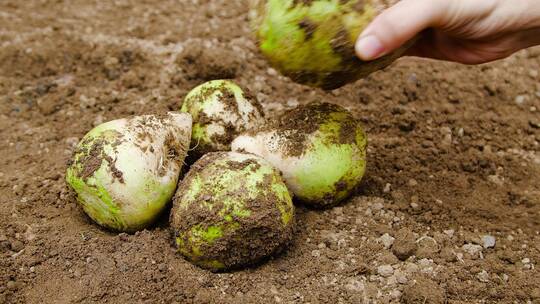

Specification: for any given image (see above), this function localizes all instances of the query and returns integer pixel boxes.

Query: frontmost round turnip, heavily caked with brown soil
[170,152,294,271]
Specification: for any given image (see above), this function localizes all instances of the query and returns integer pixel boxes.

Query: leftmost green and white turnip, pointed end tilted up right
[66,113,192,232]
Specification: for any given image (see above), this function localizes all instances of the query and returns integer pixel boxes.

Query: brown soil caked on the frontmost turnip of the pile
[171,152,294,270]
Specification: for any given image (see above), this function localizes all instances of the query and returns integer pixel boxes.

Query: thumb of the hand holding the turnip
[355,0,452,61]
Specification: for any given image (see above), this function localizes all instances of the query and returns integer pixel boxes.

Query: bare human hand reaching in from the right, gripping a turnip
[356,0,540,64]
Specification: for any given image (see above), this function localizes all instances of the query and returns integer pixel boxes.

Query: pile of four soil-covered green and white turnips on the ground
[66,80,367,271]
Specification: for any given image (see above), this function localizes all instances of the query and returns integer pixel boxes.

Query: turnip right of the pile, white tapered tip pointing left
[231,102,367,206]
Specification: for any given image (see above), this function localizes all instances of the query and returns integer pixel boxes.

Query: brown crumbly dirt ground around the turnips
[0,0,540,303]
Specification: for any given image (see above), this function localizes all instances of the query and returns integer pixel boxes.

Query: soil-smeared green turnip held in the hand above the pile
[250,0,410,90]
